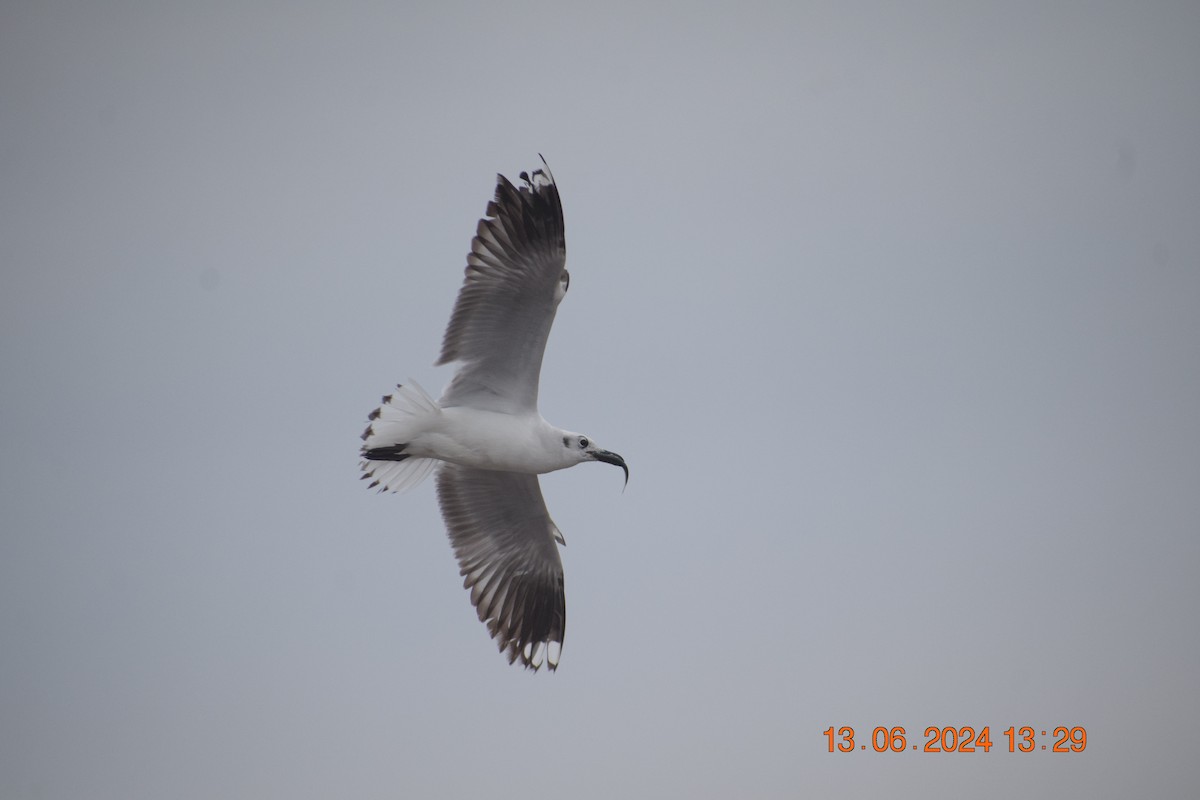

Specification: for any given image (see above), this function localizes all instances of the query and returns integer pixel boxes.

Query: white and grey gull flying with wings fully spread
[361,160,629,670]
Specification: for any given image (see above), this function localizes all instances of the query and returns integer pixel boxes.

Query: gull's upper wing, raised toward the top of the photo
[438,161,569,413]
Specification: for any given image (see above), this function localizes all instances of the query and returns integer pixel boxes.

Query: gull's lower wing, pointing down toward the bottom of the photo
[438,463,566,670]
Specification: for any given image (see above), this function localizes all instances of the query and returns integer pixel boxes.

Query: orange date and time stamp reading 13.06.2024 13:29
[822,726,1087,753]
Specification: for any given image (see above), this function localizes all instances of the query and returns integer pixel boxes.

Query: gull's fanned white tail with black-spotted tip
[359,378,442,492]
